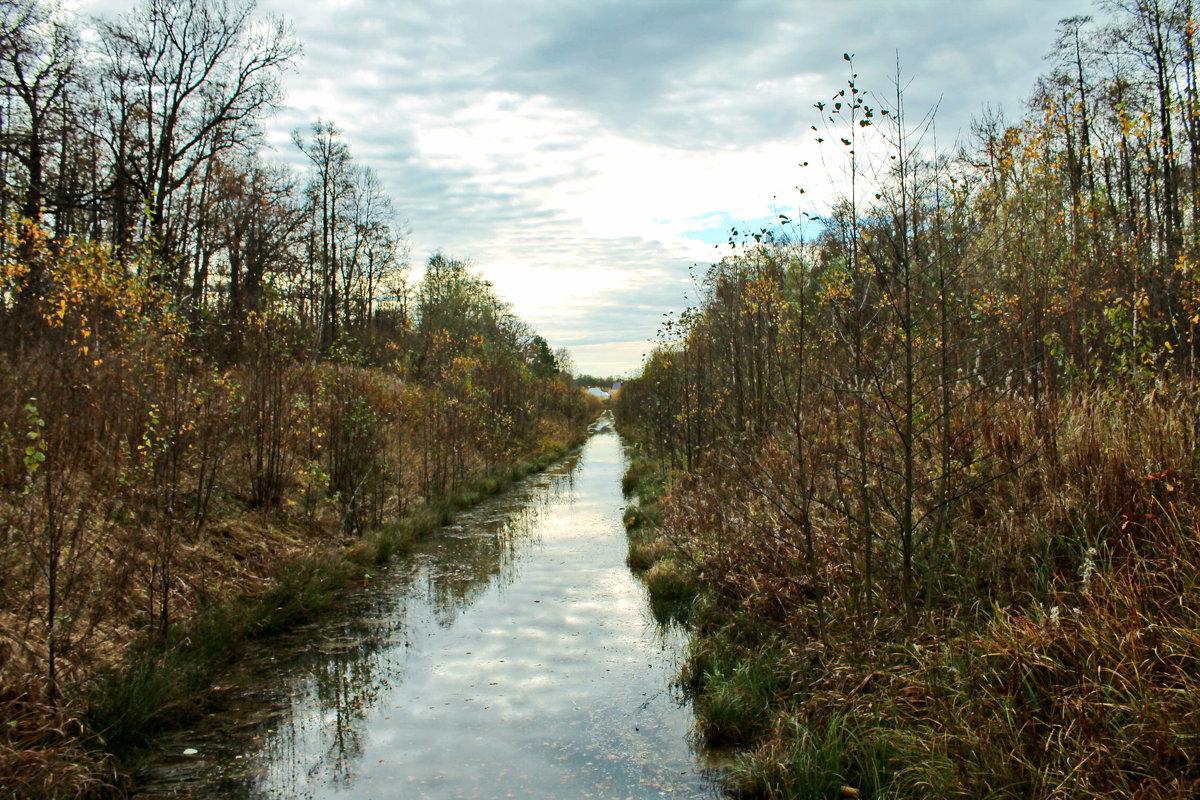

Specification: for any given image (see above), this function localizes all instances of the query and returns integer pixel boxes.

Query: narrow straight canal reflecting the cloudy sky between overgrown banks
[137,432,720,800]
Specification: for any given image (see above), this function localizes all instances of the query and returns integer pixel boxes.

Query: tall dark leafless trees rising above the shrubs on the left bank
[0,0,407,355]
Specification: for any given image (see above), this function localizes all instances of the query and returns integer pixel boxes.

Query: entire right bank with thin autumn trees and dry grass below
[618,0,1200,798]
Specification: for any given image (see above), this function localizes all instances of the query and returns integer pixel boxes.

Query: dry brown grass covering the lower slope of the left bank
[0,371,582,798]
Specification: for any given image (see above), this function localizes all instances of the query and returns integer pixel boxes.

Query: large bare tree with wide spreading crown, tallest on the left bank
[101,0,299,266]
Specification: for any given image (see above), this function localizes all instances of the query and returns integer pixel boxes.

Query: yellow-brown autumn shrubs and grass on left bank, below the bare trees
[0,235,588,794]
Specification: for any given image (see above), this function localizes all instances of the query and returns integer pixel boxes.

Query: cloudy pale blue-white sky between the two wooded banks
[77,0,1092,375]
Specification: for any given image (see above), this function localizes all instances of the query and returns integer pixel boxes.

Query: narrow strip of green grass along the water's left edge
[84,441,580,760]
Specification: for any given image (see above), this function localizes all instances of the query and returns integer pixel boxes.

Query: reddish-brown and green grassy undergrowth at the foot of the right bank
[629,396,1200,800]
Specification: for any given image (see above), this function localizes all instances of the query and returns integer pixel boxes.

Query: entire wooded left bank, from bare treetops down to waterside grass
[0,0,595,798]
